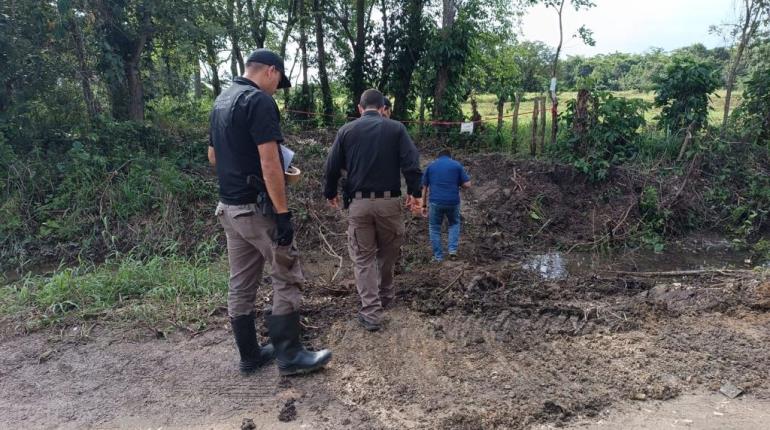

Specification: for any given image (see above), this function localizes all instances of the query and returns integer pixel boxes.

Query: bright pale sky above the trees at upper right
[521,0,736,56]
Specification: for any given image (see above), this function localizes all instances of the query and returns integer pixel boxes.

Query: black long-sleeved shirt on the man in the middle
[324,111,422,199]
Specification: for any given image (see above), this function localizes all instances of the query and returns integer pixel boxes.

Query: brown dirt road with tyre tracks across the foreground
[0,276,770,429]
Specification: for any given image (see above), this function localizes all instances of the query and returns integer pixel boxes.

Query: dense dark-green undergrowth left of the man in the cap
[0,122,216,269]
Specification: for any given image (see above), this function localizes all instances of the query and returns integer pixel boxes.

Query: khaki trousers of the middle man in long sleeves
[348,198,404,323]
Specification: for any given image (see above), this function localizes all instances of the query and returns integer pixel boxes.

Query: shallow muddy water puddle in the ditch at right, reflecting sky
[522,237,770,280]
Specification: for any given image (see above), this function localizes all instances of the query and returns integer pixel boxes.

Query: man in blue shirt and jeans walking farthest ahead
[422,149,471,261]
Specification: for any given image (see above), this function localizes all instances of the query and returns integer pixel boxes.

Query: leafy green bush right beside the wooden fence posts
[555,90,650,180]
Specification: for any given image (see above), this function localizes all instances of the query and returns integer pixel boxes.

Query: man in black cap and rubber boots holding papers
[209,49,331,375]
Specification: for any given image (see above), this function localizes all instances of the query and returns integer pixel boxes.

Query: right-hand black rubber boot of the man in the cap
[268,312,332,376]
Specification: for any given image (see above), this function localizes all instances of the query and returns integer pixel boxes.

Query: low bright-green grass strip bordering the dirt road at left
[0,256,228,332]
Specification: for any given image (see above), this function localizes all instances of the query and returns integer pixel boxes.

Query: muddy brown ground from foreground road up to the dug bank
[0,142,770,429]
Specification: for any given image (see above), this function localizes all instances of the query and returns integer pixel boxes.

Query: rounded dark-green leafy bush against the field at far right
[653,55,722,133]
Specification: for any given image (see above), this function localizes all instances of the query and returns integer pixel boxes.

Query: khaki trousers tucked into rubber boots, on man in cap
[216,203,305,318]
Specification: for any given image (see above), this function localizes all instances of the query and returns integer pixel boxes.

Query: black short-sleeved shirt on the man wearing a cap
[209,77,283,205]
